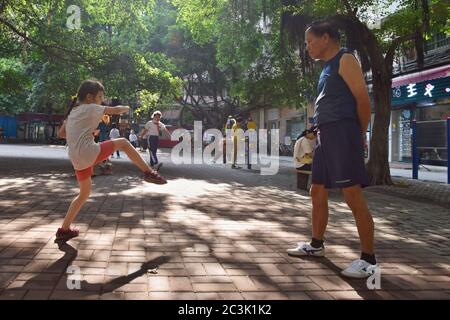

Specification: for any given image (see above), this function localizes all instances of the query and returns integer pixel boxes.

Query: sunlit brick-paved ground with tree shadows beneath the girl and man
[0,147,450,299]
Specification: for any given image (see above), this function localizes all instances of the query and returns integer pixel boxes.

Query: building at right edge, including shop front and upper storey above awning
[389,35,450,166]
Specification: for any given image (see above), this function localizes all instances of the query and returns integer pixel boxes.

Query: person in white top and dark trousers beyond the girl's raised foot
[141,111,170,171]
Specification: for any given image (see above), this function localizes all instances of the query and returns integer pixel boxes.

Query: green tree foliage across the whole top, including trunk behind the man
[0,0,450,184]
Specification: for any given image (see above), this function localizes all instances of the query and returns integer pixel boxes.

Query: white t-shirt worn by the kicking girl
[66,104,106,170]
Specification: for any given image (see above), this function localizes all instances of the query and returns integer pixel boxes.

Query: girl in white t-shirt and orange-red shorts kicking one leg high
[56,80,167,241]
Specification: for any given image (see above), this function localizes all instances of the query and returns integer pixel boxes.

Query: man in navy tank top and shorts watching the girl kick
[288,21,379,278]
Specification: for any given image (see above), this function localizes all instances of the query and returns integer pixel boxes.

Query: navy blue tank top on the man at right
[314,48,358,126]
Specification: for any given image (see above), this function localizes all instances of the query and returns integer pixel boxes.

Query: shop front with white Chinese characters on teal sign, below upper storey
[389,66,450,165]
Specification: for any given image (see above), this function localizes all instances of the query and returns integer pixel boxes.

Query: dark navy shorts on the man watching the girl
[312,119,369,189]
